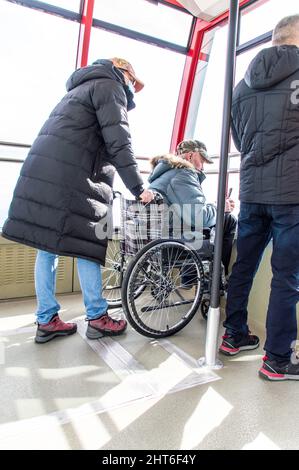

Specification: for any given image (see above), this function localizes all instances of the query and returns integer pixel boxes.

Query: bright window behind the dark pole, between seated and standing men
[185,19,270,208]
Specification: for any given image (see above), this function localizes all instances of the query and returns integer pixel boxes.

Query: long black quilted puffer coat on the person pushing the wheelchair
[2,62,142,264]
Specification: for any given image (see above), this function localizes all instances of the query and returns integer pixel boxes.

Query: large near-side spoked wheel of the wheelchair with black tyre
[122,240,204,338]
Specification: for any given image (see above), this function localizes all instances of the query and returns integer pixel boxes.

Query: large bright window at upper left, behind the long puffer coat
[0,1,79,144]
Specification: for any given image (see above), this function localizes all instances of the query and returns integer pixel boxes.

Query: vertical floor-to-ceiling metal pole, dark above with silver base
[200,0,239,368]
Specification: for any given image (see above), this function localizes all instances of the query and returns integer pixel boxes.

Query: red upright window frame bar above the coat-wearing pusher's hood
[76,0,95,68]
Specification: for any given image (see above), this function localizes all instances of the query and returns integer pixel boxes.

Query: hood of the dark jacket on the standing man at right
[244,46,299,89]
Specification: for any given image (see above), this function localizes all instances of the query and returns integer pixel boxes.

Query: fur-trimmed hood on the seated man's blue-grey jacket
[148,154,205,183]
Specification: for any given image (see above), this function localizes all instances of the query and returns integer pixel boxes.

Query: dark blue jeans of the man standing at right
[224,203,299,361]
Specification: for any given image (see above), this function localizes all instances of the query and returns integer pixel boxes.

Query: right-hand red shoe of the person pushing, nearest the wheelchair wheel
[86,313,127,339]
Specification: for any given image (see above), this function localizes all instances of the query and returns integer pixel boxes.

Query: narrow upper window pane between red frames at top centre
[94,0,192,46]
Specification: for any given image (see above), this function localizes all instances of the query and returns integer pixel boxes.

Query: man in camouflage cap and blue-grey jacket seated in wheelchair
[148,140,237,286]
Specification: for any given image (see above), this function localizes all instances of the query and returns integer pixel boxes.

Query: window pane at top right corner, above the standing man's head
[240,0,299,44]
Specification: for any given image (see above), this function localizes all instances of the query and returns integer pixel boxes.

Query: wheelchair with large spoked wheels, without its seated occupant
[103,194,224,338]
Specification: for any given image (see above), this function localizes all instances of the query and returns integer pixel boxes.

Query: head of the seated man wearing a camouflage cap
[176,140,213,171]
